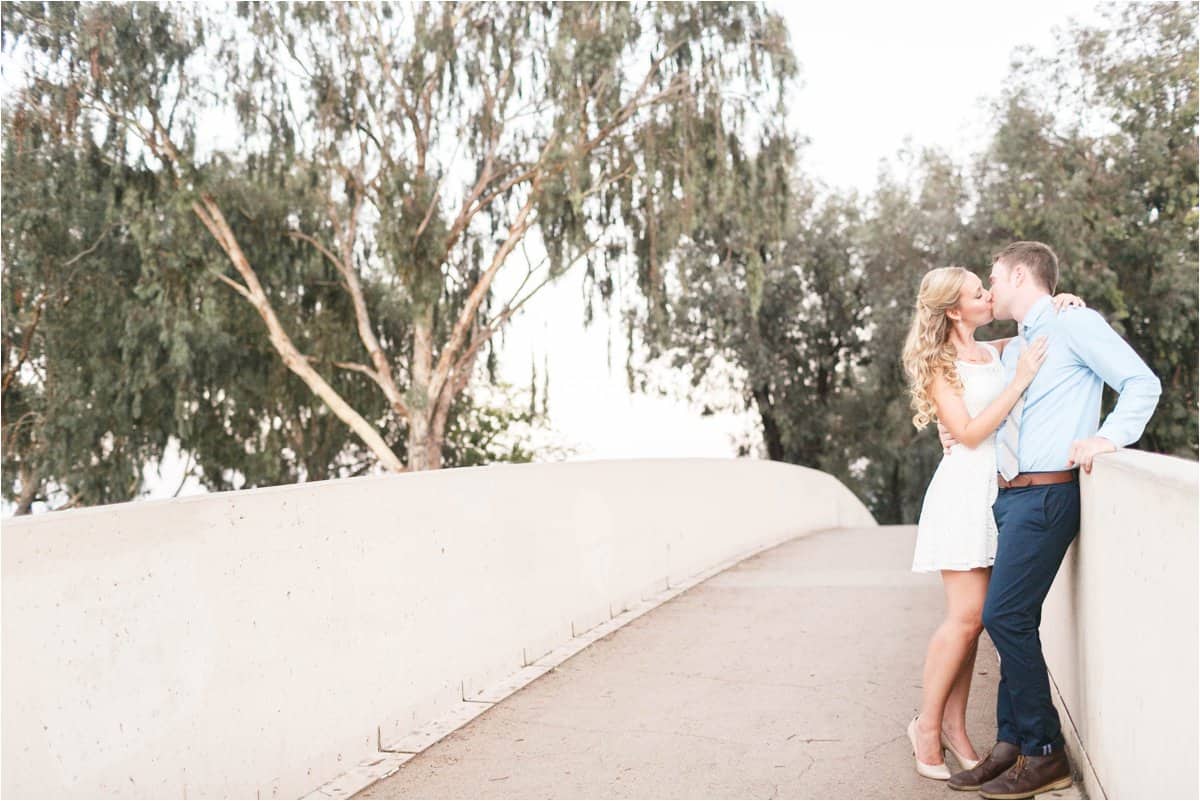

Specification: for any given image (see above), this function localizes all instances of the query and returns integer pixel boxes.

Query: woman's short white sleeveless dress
[912,343,1008,573]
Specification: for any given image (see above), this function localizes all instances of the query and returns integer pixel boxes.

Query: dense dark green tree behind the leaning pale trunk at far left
[0,103,427,514]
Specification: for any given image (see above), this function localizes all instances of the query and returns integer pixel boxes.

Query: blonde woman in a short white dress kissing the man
[904,267,1084,781]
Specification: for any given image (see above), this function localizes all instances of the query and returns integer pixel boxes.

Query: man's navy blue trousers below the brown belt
[983,481,1079,755]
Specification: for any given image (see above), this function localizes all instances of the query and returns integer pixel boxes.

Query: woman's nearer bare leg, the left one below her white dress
[917,568,989,765]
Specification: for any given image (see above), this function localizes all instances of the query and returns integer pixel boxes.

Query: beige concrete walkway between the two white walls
[355,526,1078,799]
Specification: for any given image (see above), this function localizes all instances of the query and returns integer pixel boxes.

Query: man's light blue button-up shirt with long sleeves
[1002,295,1163,472]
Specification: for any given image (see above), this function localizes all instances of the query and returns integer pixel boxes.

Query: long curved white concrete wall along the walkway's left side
[2,459,878,797]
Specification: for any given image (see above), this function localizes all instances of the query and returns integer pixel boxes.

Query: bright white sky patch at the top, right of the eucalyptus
[782,0,1099,192]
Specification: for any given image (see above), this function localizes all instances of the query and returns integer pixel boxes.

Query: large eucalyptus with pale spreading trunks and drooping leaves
[5,2,794,470]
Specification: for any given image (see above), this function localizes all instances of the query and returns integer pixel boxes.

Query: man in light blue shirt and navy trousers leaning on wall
[938,242,1162,799]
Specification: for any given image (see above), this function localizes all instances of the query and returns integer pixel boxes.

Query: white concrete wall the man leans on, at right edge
[1042,451,1200,799]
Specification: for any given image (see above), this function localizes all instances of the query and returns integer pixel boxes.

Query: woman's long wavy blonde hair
[901,267,971,430]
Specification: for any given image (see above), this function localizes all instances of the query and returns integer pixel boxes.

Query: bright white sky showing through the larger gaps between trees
[23,0,1097,510]
